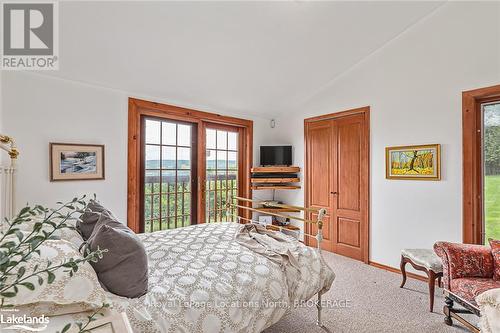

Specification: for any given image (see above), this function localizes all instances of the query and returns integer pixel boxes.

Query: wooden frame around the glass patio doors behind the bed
[127,98,253,232]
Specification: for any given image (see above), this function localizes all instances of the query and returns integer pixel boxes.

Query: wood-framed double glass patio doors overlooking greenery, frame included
[128,99,253,232]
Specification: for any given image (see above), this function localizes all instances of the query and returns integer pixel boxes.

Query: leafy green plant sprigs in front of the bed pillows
[0,196,109,333]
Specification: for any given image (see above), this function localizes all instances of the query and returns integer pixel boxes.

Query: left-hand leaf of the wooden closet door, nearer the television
[305,120,335,251]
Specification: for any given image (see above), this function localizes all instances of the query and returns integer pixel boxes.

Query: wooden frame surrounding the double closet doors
[304,106,370,263]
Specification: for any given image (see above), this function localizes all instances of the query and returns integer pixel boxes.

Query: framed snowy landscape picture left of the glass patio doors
[49,143,104,181]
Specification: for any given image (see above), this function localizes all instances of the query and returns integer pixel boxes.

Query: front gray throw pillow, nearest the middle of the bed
[87,212,148,298]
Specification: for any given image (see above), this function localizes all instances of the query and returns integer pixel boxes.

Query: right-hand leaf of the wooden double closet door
[331,114,368,260]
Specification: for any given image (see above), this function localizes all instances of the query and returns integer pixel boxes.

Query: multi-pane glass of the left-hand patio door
[143,118,196,232]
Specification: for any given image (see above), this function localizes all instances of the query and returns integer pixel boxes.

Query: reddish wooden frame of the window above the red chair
[462,85,500,244]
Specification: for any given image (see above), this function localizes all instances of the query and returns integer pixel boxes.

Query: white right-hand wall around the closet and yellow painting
[275,2,500,267]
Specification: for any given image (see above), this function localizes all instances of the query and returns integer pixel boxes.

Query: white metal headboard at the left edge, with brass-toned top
[0,134,19,223]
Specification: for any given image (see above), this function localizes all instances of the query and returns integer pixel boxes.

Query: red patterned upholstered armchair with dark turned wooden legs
[434,242,500,332]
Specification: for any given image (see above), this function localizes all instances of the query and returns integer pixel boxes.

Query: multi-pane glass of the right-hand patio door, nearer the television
[204,128,238,222]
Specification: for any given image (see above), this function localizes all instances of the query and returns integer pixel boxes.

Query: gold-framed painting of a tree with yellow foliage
[385,144,441,180]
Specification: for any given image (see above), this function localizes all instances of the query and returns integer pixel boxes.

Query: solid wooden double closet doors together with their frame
[305,108,369,262]
